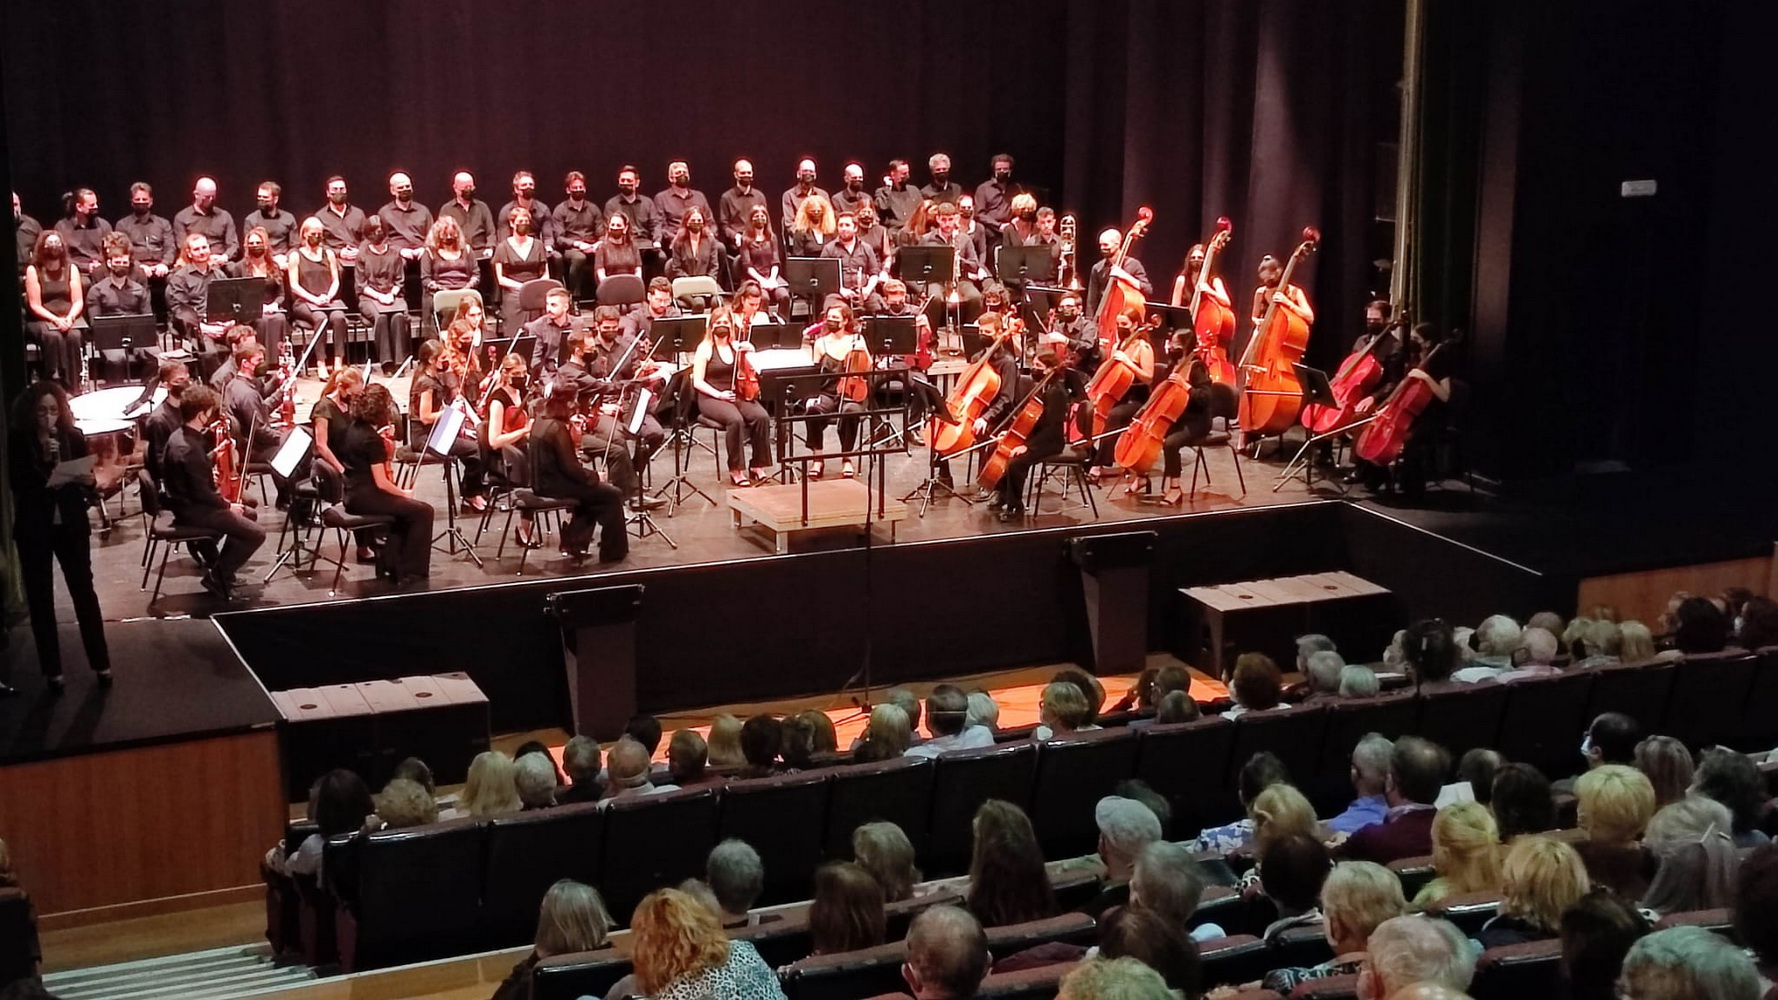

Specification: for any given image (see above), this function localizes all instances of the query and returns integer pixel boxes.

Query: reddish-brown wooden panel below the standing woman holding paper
[0,730,288,918]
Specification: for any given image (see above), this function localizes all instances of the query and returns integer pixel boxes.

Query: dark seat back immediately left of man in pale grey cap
[1031,728,1136,858]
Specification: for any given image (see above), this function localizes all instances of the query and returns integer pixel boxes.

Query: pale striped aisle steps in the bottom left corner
[43,945,315,1000]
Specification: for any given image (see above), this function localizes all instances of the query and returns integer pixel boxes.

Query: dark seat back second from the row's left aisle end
[482,802,605,948]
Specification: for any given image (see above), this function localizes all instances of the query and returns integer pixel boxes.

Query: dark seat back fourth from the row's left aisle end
[717,770,829,906]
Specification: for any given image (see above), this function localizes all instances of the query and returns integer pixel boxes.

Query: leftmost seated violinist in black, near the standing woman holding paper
[160,386,265,600]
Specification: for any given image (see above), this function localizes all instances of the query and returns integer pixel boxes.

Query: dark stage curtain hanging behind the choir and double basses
[4,0,1401,371]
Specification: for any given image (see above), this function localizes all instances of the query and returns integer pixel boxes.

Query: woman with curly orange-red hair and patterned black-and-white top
[629,890,784,1000]
